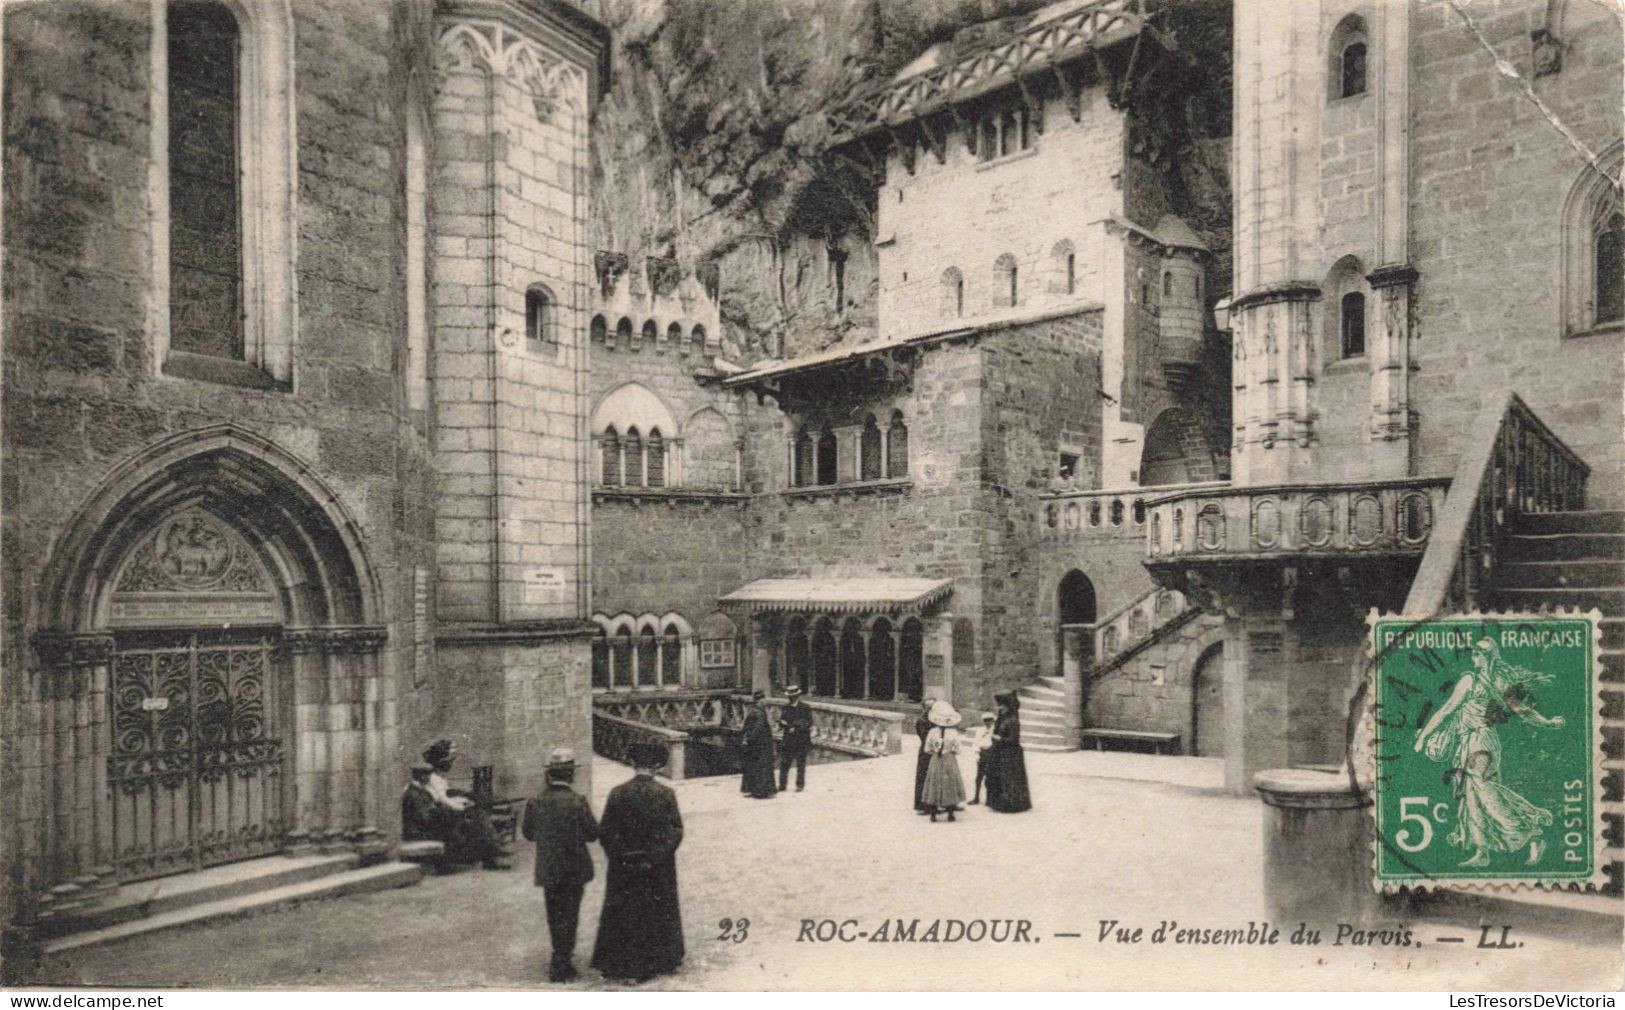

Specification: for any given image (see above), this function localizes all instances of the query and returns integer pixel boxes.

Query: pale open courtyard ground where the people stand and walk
[28,753,1620,991]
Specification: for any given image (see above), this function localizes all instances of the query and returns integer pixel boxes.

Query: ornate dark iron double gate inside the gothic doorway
[107,628,286,880]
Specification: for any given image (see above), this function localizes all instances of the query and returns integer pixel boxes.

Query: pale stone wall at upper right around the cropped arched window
[1411,2,1625,508]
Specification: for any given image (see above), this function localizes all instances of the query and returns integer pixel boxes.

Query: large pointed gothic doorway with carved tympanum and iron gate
[34,425,393,880]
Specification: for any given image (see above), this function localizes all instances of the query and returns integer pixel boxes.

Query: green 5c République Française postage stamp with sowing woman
[1372,611,1604,890]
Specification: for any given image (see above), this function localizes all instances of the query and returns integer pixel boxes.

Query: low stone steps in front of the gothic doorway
[39,852,424,955]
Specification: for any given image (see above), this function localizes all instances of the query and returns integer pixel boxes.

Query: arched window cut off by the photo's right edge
[1563,143,1625,335]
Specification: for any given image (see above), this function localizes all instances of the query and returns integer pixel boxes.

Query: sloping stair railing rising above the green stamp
[1406,393,1591,617]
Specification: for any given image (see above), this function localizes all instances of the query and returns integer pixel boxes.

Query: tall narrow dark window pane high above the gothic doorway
[169,3,247,359]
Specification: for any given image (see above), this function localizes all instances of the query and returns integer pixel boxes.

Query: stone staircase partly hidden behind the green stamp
[1490,511,1625,895]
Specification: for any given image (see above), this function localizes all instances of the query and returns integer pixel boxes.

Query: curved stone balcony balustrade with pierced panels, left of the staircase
[1146,477,1450,565]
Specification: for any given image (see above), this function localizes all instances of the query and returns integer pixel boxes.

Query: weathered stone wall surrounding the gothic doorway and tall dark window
[0,3,429,909]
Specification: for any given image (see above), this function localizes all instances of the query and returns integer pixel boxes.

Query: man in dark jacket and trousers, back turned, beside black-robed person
[523,747,598,982]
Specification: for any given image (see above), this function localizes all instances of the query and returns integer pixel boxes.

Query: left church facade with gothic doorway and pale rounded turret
[0,0,608,935]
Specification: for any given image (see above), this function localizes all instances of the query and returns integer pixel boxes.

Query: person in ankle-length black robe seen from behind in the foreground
[593,744,683,982]
